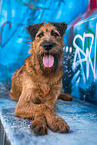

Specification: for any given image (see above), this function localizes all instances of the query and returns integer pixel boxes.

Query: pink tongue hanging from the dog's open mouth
[43,55,54,67]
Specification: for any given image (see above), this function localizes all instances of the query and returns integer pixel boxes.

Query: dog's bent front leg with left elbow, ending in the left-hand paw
[15,89,48,135]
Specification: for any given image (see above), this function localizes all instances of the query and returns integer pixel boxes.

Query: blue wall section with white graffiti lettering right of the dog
[63,5,97,102]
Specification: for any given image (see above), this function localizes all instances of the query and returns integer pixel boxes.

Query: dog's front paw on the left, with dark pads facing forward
[30,120,48,135]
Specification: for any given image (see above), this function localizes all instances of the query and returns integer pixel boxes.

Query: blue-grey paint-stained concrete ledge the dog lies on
[0,97,97,145]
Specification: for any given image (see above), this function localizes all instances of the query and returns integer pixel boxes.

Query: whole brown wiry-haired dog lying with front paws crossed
[9,23,72,135]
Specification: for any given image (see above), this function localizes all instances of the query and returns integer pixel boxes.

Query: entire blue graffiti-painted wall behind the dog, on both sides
[0,0,97,102]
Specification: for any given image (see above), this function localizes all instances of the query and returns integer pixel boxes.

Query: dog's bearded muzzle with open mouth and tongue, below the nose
[37,42,63,75]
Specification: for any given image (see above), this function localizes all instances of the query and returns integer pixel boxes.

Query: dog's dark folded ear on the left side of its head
[27,23,44,41]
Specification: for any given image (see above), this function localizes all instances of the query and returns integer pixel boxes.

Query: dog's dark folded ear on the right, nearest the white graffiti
[51,22,67,37]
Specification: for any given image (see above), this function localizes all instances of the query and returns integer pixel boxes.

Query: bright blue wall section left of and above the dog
[0,0,88,81]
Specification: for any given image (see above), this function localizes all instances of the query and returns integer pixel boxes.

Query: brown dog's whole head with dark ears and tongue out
[27,23,67,74]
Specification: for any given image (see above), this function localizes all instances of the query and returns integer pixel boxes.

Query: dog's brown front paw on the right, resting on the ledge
[49,116,70,133]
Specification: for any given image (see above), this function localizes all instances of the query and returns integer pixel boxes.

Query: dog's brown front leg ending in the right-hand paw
[42,89,69,133]
